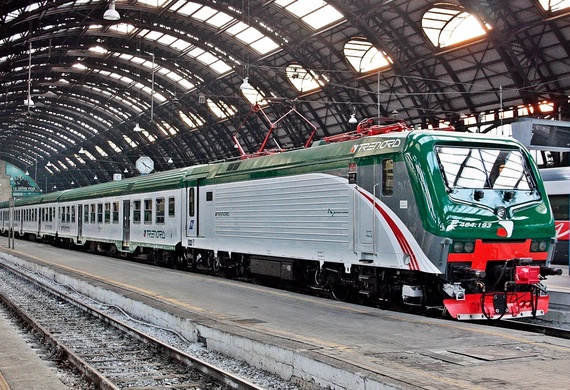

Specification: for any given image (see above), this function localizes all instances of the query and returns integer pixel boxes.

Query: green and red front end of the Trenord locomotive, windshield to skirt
[408,136,561,319]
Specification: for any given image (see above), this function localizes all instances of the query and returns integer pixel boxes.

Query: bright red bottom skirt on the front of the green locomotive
[443,290,549,320]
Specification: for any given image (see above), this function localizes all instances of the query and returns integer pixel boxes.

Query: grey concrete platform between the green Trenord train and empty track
[0,241,570,390]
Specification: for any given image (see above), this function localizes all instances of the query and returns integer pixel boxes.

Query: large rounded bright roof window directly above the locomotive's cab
[422,4,491,48]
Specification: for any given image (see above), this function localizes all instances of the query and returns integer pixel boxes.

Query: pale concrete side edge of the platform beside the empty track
[3,248,408,390]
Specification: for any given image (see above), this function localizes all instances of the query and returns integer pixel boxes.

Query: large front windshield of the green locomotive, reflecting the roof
[436,146,535,190]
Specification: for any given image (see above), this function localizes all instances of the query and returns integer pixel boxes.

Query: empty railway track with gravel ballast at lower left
[0,265,263,390]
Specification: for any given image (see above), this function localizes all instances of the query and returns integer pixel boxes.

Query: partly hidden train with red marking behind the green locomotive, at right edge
[540,166,570,265]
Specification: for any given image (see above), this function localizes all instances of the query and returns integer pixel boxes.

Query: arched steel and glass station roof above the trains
[0,0,570,191]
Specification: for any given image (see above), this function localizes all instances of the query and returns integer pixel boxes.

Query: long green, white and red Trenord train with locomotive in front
[0,124,561,320]
